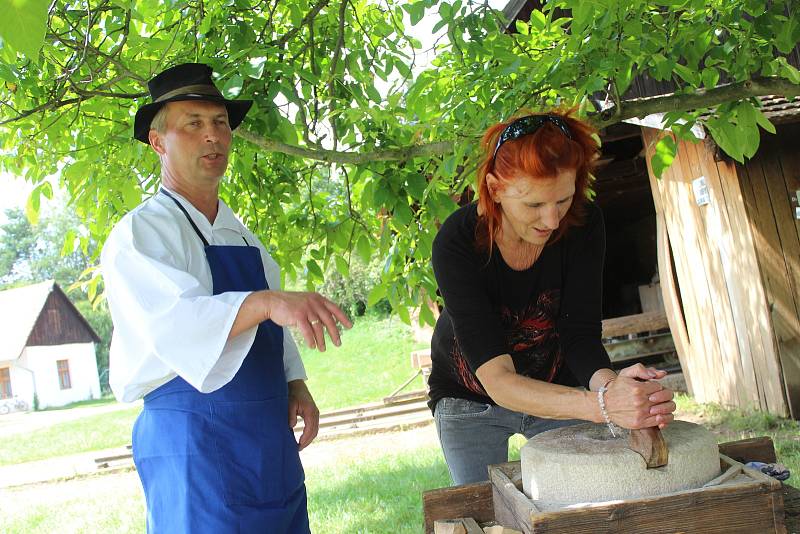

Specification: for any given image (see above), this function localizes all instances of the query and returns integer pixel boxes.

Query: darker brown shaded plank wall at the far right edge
[736,123,800,419]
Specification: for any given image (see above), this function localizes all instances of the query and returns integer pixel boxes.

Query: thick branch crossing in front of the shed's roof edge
[590,77,800,128]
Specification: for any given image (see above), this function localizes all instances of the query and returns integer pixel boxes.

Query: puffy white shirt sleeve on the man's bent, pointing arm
[101,207,256,401]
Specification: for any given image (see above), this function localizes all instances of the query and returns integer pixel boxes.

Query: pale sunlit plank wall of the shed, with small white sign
[642,128,788,415]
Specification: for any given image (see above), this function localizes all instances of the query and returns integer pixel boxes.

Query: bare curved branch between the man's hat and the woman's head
[233,128,455,165]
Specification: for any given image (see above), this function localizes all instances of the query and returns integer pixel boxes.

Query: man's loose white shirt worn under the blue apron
[100,191,306,402]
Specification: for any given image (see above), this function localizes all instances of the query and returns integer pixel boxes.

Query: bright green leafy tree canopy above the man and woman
[0,0,800,321]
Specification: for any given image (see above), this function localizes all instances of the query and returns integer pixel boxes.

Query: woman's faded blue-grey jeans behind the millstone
[434,397,585,485]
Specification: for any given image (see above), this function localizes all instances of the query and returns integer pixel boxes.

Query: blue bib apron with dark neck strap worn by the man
[133,189,310,534]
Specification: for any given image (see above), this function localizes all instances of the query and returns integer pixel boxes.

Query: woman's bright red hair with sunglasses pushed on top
[475,109,600,253]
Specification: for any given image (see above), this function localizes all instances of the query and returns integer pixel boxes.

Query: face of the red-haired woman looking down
[486,169,575,245]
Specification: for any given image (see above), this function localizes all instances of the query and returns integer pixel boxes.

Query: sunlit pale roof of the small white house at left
[0,280,97,360]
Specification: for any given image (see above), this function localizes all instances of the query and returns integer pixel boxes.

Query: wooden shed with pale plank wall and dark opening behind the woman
[504,0,800,419]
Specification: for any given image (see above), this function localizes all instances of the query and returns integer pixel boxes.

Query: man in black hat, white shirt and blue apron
[101,63,351,534]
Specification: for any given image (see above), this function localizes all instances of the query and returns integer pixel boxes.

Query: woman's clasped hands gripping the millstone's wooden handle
[605,363,675,434]
